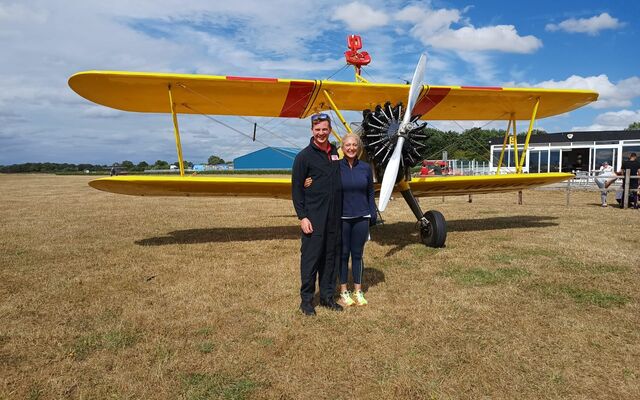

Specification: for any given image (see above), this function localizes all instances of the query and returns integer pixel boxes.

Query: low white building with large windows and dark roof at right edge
[490,130,640,173]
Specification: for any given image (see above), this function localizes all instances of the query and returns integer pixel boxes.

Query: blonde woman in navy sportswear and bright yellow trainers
[305,133,376,307]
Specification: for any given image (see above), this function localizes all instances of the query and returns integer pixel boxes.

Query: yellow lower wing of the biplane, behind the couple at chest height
[89,173,573,199]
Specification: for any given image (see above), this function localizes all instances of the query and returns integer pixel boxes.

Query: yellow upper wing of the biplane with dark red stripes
[69,71,598,120]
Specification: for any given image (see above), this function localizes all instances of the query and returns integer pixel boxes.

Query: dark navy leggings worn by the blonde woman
[340,217,369,285]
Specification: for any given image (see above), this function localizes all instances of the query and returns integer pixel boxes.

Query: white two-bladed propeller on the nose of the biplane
[378,54,427,211]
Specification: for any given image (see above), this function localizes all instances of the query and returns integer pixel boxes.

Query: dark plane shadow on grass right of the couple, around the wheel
[371,215,558,256]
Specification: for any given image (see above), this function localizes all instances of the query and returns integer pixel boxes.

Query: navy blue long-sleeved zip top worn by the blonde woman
[340,158,377,224]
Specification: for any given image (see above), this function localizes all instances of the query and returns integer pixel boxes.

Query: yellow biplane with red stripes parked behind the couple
[69,35,598,247]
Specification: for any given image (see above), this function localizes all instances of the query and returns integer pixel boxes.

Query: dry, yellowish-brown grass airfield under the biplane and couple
[0,175,640,399]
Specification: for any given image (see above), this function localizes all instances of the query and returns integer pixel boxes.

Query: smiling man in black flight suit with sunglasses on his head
[291,114,342,315]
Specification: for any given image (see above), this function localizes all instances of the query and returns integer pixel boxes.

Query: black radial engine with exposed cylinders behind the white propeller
[361,102,427,182]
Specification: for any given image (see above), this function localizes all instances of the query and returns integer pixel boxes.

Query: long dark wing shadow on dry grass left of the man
[135,225,300,246]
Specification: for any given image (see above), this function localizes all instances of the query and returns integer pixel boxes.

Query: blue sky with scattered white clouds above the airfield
[0,0,640,165]
